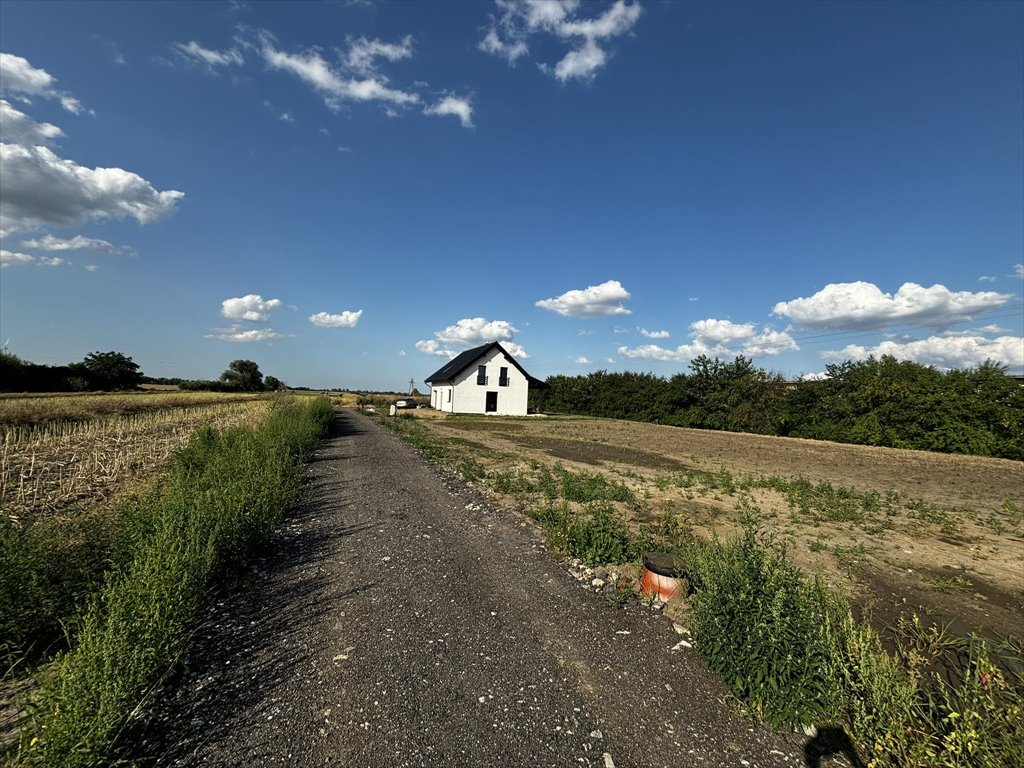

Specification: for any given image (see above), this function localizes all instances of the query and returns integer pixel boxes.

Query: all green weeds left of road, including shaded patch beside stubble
[0,395,332,766]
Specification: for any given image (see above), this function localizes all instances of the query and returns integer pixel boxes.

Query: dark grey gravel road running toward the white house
[135,410,807,768]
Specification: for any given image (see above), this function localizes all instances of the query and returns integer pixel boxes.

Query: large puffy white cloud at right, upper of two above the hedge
[772,281,1012,330]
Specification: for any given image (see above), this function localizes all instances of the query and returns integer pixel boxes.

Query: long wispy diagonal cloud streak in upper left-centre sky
[259,32,420,111]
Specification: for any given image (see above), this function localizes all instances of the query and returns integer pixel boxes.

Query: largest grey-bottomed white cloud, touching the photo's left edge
[0,144,184,236]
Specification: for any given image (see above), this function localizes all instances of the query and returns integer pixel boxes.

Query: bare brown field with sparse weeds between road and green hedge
[401,412,1024,638]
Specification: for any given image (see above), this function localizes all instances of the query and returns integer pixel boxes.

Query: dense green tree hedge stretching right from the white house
[544,355,1024,460]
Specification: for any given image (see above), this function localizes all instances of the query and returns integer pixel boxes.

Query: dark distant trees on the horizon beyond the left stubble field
[0,350,286,392]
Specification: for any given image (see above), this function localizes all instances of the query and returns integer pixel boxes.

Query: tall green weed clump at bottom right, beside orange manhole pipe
[683,520,1024,768]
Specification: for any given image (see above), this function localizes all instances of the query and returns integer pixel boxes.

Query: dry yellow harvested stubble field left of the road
[0,392,270,522]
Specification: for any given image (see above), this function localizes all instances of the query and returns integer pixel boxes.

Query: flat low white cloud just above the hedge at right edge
[821,336,1024,371]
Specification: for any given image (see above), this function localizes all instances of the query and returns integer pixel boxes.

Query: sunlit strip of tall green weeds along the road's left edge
[23,398,332,768]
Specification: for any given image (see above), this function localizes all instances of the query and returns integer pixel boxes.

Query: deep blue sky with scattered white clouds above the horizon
[0,0,1024,389]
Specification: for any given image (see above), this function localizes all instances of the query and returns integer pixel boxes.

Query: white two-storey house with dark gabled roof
[427,341,548,416]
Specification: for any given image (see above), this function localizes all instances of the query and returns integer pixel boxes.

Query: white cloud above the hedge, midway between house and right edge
[618,318,800,361]
